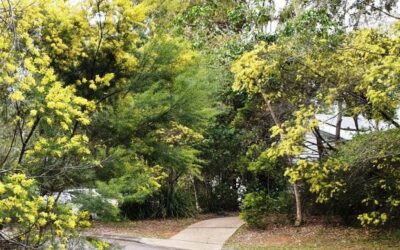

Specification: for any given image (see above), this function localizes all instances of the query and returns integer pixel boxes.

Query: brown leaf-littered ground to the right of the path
[225,217,400,250]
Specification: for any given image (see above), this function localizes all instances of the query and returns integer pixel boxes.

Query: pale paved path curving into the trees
[96,217,244,250]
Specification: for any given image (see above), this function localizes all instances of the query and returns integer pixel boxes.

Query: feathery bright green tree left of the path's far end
[87,35,218,217]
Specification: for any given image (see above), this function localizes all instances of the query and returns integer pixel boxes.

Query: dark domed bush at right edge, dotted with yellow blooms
[314,129,400,226]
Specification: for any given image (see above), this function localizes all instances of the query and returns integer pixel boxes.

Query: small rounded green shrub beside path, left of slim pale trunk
[240,191,292,229]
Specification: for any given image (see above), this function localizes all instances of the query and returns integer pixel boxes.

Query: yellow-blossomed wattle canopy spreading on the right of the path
[231,12,400,226]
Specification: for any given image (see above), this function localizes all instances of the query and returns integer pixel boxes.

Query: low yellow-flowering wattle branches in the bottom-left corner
[0,174,90,249]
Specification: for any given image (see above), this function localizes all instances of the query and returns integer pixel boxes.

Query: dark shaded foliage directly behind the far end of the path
[195,122,241,212]
